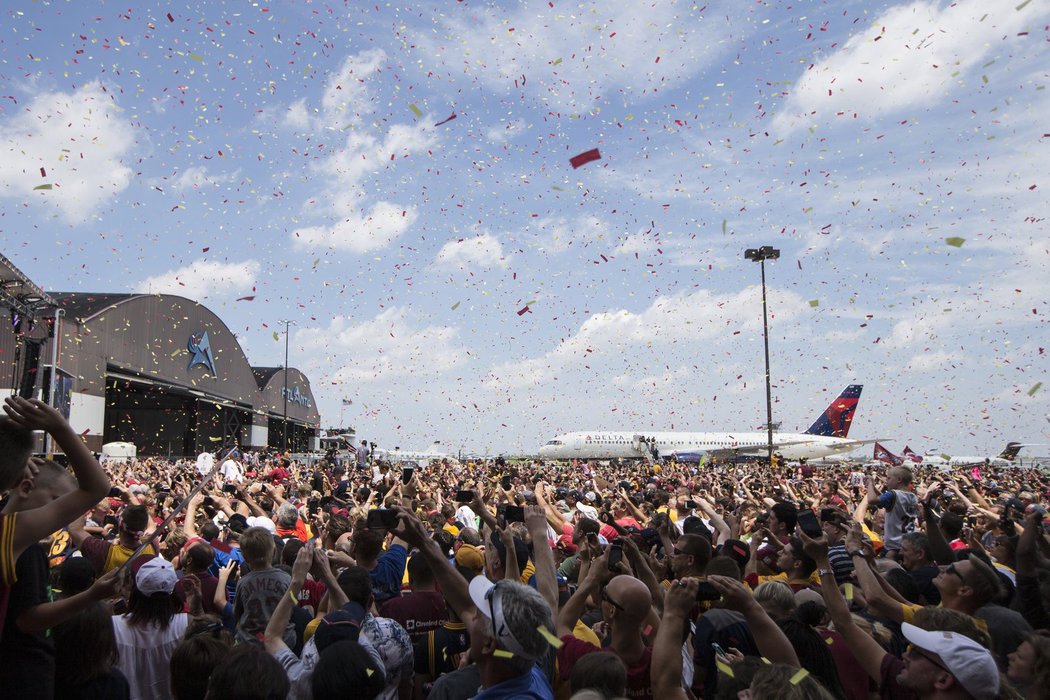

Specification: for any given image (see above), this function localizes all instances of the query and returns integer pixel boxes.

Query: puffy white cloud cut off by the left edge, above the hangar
[0,81,134,224]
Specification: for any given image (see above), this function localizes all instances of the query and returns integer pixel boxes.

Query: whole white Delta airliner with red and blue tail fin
[540,384,875,461]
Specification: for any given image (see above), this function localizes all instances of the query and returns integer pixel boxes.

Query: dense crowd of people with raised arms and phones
[0,398,1050,700]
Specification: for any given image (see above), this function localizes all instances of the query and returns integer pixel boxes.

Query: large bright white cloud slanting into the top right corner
[774,0,1050,132]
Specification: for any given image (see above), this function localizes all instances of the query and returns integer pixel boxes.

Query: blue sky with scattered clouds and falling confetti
[0,0,1050,453]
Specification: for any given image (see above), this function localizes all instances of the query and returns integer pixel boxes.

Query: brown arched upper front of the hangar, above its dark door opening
[51,293,320,426]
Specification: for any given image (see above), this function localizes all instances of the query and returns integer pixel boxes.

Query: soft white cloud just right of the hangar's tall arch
[294,307,466,390]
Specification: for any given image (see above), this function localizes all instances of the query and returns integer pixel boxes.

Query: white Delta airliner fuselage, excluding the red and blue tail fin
[540,431,859,460]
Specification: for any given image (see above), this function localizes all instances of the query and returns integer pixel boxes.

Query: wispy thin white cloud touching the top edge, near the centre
[413,0,748,111]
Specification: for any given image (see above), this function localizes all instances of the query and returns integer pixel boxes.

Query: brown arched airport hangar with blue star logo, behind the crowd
[0,256,320,457]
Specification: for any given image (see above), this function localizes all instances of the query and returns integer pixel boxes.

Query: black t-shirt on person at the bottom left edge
[0,545,55,700]
